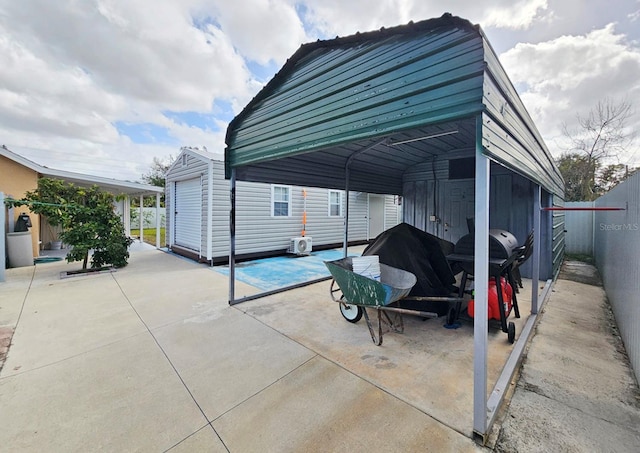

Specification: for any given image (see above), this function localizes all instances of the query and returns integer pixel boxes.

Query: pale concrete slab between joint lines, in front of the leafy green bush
[2,263,146,376]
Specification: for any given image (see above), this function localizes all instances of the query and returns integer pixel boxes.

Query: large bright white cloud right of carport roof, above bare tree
[500,24,640,161]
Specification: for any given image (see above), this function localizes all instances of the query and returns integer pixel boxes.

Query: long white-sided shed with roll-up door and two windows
[165,148,402,263]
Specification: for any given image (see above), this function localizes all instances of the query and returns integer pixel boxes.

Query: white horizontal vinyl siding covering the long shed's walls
[166,151,401,260]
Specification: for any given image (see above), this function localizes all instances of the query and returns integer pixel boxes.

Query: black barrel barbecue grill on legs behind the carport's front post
[447,229,523,343]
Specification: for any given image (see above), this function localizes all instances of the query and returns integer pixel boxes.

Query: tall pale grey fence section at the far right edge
[593,173,640,381]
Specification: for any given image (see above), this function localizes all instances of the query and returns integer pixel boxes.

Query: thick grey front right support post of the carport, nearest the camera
[473,117,490,434]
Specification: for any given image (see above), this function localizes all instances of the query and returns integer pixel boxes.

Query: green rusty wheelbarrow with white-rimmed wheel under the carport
[325,257,461,346]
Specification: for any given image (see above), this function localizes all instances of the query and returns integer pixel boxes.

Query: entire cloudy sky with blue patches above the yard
[0,0,640,180]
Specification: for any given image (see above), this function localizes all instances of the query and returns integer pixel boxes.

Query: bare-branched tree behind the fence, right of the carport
[558,98,634,201]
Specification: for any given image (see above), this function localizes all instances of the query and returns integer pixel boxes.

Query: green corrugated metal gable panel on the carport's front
[226,17,484,168]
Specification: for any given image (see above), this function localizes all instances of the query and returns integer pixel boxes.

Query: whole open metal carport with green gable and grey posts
[225,14,564,438]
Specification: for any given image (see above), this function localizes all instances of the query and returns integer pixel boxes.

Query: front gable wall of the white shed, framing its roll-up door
[165,153,208,254]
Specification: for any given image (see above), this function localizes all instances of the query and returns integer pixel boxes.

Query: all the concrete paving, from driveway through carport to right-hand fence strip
[0,250,640,452]
